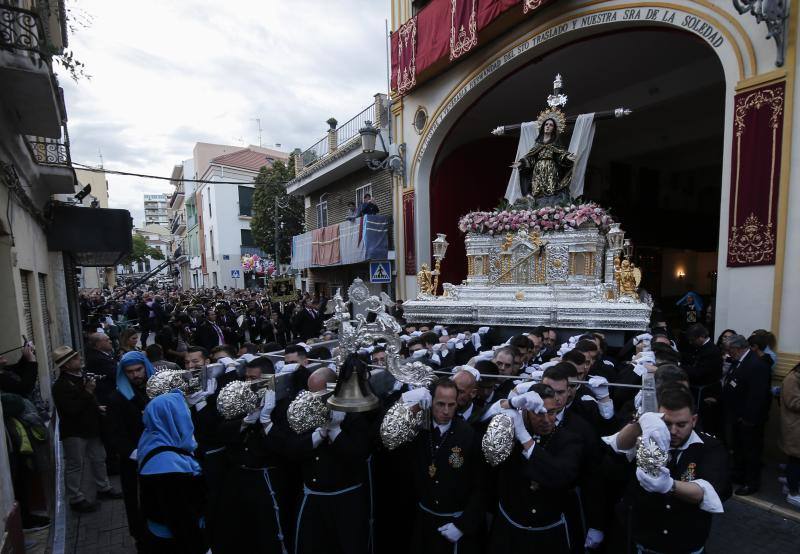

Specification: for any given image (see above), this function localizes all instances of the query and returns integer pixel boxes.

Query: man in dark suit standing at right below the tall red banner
[722,335,770,496]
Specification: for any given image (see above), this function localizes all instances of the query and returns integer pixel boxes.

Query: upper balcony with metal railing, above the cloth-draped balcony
[286,94,389,196]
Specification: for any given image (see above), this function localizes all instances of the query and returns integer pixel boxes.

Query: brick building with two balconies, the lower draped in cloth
[286,94,395,296]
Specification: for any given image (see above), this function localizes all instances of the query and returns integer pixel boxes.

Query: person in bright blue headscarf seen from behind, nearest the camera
[137,391,208,554]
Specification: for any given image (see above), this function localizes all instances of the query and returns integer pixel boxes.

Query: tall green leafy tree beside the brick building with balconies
[250,156,305,264]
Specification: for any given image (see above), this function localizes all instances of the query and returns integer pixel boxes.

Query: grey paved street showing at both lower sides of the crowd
[66,478,800,554]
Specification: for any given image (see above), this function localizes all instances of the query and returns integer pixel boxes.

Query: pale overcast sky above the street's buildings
[58,0,388,225]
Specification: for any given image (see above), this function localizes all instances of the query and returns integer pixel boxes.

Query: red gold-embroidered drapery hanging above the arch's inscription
[391,0,553,94]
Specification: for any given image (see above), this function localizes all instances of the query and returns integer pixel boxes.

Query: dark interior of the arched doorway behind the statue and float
[429,27,725,326]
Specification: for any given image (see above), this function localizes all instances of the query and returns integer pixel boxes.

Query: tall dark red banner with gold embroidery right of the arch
[727,81,786,267]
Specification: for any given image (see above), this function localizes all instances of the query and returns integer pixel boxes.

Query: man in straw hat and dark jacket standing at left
[53,346,122,512]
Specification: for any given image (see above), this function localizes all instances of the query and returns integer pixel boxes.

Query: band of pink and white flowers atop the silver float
[458,202,614,235]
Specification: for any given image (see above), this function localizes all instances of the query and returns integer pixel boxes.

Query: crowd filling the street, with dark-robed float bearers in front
[0,282,800,553]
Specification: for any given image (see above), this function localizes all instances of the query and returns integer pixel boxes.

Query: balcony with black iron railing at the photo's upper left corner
[0,4,66,138]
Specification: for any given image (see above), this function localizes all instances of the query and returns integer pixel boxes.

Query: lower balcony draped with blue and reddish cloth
[292,215,391,269]
